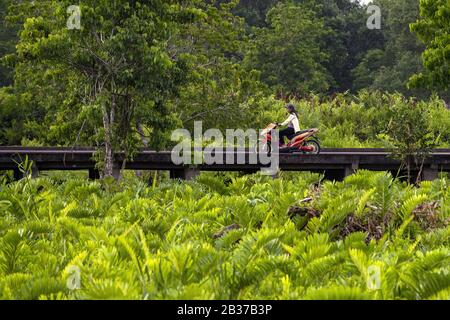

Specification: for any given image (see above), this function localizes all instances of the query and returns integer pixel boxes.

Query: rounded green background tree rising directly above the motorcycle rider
[246,2,330,95]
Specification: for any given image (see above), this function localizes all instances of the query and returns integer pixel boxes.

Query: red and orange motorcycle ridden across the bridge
[256,123,320,154]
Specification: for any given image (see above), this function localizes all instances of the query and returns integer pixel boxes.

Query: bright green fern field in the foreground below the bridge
[0,171,450,299]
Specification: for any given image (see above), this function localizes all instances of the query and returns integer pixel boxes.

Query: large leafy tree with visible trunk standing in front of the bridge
[5,0,200,176]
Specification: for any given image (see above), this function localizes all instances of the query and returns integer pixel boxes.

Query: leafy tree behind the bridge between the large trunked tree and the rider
[171,1,264,129]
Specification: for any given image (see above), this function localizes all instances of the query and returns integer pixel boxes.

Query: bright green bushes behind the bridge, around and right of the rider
[254,91,450,149]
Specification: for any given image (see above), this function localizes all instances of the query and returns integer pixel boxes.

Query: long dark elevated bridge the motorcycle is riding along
[0,147,450,180]
